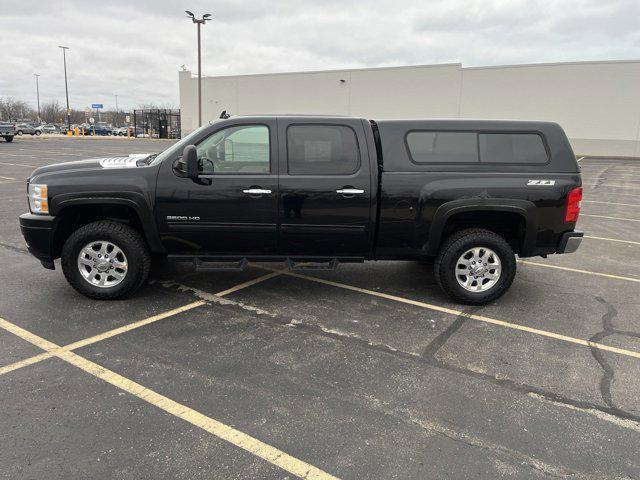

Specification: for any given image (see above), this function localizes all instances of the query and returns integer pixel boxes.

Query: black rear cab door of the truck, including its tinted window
[278,117,373,257]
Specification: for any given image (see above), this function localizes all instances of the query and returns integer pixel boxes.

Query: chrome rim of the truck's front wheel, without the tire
[78,240,129,288]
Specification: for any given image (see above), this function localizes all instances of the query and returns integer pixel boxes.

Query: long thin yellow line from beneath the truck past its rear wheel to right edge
[260,267,640,358]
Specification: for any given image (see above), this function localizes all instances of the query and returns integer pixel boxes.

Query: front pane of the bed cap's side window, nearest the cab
[407,132,478,163]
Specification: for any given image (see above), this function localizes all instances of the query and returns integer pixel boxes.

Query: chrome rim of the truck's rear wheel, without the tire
[456,247,502,292]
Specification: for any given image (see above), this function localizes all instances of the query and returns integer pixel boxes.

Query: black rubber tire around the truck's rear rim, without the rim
[433,228,516,305]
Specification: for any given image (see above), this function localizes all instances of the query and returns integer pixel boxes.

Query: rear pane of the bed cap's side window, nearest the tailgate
[479,133,549,163]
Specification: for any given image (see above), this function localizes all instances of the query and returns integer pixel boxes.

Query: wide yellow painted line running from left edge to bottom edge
[0,318,337,480]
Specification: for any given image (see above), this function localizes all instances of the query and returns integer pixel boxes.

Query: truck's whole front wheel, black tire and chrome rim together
[61,221,151,300]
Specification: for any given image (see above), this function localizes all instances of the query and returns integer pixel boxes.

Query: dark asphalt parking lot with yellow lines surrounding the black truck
[0,138,640,479]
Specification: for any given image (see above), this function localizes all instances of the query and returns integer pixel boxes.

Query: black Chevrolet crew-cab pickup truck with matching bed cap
[20,116,582,304]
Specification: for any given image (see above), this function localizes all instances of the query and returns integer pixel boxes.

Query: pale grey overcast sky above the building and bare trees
[0,0,640,108]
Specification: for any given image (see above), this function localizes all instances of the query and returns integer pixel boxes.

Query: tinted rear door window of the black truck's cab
[287,125,360,175]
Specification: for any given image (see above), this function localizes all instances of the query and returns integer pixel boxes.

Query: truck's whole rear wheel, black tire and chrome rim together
[434,229,516,305]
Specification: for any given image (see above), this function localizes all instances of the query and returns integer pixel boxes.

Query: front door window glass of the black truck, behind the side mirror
[196,125,271,175]
